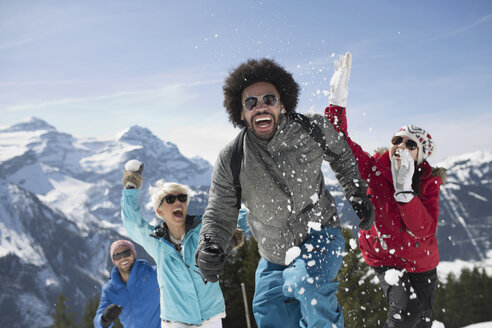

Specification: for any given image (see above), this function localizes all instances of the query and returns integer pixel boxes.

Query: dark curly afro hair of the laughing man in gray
[223,58,299,127]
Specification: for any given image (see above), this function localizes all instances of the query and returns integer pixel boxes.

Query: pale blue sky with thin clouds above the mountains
[0,0,492,164]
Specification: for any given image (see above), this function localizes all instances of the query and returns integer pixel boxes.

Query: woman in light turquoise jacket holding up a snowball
[121,160,247,328]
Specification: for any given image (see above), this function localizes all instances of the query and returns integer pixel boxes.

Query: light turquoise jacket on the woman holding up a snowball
[121,189,247,325]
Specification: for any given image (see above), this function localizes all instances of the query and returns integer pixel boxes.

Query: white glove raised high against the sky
[328,52,352,107]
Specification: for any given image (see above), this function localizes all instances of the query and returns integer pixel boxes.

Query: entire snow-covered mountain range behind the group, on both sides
[0,118,492,327]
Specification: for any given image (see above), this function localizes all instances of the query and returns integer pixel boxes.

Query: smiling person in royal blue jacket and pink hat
[94,239,161,328]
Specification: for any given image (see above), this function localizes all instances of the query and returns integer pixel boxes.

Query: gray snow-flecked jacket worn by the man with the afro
[200,115,367,265]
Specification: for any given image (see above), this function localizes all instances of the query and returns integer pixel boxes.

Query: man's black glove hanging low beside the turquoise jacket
[195,241,226,282]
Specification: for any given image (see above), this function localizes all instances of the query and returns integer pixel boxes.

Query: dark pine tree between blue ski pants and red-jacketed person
[337,228,388,328]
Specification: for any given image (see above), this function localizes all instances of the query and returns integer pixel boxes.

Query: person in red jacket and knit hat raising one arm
[325,53,445,328]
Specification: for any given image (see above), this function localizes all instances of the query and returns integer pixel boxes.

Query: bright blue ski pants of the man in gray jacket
[253,227,345,328]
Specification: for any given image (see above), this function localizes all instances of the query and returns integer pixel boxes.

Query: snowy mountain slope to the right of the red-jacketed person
[437,151,492,261]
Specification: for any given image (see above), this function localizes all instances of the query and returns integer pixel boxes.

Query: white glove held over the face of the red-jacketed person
[391,149,415,203]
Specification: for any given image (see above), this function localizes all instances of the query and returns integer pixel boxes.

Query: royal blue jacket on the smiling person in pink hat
[94,260,161,328]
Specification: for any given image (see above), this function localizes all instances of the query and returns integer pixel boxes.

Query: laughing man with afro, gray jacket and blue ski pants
[196,59,374,328]
